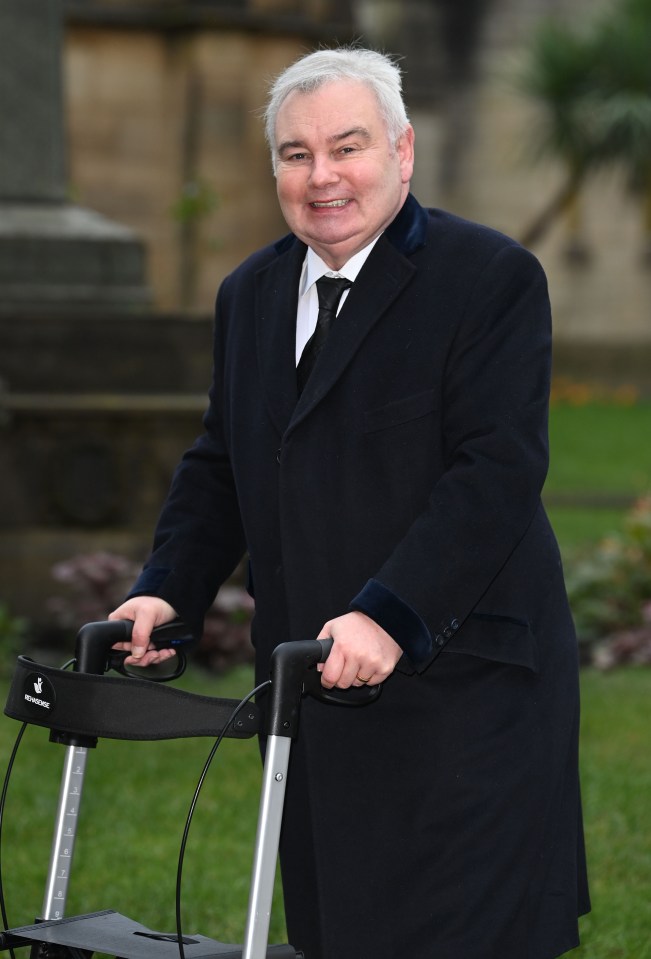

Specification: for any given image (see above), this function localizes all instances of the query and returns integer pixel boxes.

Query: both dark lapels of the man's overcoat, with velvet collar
[256,194,428,434]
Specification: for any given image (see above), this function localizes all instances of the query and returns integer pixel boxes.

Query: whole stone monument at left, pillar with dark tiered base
[0,0,162,625]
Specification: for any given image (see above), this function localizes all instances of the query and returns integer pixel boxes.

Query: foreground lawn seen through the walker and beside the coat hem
[0,668,651,959]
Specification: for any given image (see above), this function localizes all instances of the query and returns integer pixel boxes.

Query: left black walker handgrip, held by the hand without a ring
[75,619,192,675]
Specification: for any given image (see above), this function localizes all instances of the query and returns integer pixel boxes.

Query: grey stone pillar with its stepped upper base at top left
[0,0,149,315]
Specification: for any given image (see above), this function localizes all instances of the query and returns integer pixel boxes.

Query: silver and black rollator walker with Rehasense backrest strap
[0,620,380,959]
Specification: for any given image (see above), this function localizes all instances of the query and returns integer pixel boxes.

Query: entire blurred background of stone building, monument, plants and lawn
[0,0,651,959]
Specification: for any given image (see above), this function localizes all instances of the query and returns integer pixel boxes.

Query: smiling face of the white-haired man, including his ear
[276,80,414,269]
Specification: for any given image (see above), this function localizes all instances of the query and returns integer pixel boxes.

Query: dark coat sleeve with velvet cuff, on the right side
[351,244,551,668]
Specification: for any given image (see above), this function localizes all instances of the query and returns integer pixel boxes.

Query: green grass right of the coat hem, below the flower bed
[568,668,651,959]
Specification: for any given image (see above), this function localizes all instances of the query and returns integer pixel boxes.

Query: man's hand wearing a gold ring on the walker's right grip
[317,612,402,689]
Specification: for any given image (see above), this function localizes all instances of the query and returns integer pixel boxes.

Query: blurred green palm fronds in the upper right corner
[517,0,651,256]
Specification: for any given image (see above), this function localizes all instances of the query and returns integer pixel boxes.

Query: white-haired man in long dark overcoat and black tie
[113,49,588,959]
